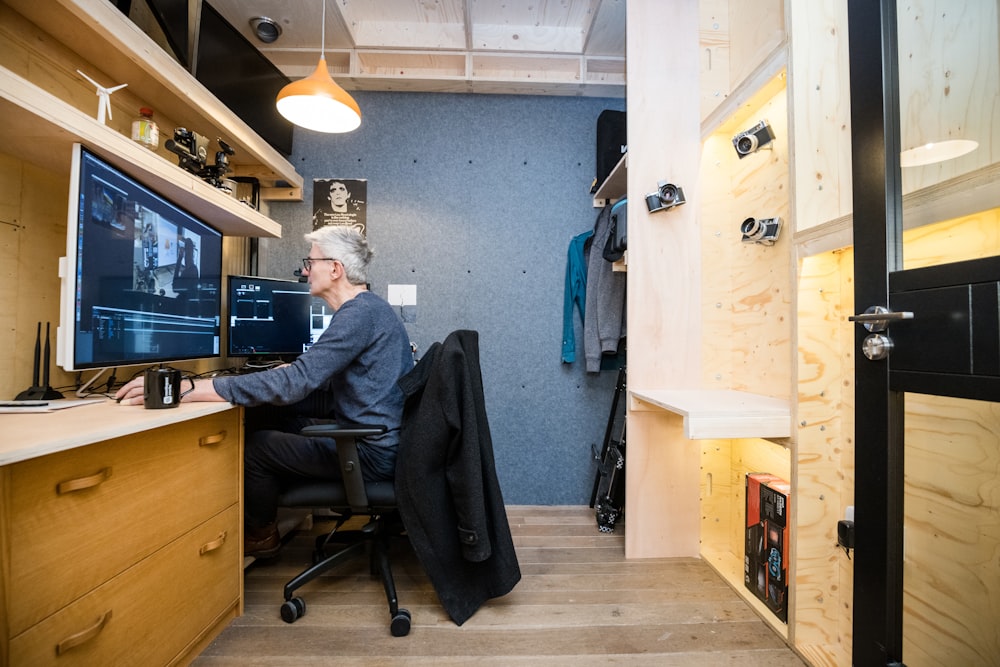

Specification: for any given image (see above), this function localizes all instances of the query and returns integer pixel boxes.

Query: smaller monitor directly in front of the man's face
[228,276,322,357]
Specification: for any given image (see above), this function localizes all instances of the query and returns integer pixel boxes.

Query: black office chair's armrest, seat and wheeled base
[279,424,410,637]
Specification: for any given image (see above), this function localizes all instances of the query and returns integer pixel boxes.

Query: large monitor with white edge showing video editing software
[57,144,222,371]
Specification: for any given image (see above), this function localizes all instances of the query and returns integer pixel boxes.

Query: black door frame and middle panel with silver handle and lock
[848,0,1000,665]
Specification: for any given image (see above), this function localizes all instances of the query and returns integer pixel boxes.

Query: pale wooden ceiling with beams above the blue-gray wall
[206,0,626,97]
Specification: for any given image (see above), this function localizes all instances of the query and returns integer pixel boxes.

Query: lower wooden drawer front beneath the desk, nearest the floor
[10,504,242,667]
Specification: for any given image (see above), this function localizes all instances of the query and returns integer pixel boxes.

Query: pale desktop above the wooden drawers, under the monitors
[0,399,233,465]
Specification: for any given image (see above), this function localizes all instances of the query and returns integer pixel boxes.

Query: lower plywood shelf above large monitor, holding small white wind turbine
[0,67,281,237]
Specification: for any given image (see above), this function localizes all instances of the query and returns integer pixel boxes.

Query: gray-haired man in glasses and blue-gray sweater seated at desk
[116,225,413,558]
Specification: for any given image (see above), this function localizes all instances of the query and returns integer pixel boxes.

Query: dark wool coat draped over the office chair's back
[396,331,521,625]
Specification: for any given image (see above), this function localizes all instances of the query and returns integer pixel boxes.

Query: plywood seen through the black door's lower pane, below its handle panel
[903,394,1000,665]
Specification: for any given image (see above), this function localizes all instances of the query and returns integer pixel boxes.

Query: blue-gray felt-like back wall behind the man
[260,92,624,505]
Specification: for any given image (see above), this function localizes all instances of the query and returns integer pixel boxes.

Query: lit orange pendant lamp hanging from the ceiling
[277,0,361,133]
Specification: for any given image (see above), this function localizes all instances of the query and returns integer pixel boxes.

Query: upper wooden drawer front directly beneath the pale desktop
[5,410,242,640]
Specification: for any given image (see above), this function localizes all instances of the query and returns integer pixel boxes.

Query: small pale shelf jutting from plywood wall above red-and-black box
[629,389,791,440]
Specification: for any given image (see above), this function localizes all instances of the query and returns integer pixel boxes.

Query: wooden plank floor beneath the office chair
[193,506,804,667]
